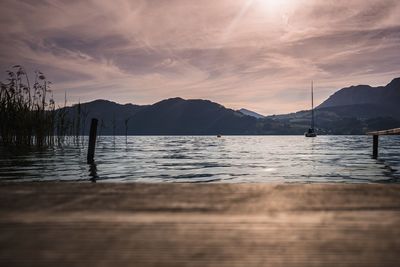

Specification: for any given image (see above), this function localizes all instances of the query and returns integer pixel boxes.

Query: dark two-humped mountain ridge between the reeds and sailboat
[65,97,258,135]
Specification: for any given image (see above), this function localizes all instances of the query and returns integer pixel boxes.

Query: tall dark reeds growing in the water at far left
[0,65,71,147]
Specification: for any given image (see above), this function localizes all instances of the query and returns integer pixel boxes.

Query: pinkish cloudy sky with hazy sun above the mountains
[0,0,400,115]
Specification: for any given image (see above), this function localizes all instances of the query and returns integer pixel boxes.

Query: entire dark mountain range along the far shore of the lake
[64,78,400,135]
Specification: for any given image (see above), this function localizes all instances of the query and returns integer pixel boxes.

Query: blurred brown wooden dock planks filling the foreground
[0,183,400,267]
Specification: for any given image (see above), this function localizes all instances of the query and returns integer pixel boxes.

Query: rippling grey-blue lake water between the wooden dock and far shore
[0,136,400,183]
